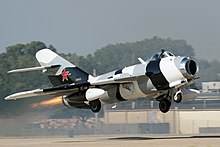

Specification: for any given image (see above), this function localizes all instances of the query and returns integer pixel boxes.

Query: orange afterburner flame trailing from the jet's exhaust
[31,96,62,108]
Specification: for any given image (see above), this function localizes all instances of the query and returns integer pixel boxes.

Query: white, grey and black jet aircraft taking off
[5,49,199,113]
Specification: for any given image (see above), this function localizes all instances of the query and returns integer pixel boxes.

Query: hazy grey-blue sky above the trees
[0,0,220,60]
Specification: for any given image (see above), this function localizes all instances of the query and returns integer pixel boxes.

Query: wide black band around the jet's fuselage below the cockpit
[146,59,169,90]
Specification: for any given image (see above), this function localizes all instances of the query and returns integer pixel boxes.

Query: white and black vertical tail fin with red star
[36,49,92,86]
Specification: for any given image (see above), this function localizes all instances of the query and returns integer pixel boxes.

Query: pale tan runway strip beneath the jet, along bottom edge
[0,136,220,147]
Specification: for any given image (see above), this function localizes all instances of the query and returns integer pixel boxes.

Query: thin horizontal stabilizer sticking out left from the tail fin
[7,65,60,73]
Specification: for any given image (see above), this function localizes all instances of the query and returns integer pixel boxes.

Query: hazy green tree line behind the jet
[0,37,220,117]
